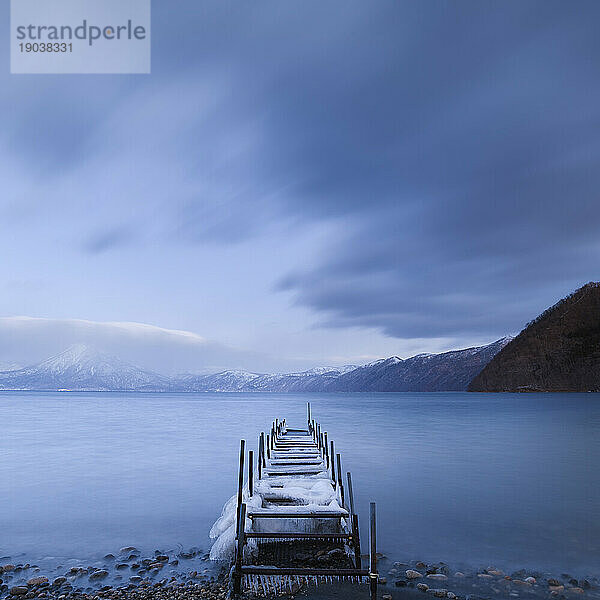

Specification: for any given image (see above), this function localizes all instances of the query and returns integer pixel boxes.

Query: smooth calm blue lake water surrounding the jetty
[0,392,600,576]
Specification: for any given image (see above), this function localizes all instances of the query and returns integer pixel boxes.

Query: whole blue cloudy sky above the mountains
[0,0,600,371]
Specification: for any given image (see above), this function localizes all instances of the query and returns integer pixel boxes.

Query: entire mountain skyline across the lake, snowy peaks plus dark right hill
[0,282,600,392]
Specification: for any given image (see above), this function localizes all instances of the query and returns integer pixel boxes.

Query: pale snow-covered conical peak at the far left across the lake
[0,345,170,391]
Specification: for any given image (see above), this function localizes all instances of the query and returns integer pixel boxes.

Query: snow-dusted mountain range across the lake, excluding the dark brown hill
[0,338,511,392]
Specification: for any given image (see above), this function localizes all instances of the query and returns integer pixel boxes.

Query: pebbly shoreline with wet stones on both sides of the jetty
[0,546,600,600]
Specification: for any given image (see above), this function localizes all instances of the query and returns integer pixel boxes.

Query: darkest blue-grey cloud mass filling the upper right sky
[236,2,600,337]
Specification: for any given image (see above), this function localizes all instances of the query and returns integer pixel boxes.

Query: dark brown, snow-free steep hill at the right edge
[469,282,600,392]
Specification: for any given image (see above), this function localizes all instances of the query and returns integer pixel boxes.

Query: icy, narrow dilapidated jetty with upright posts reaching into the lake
[230,403,378,600]
